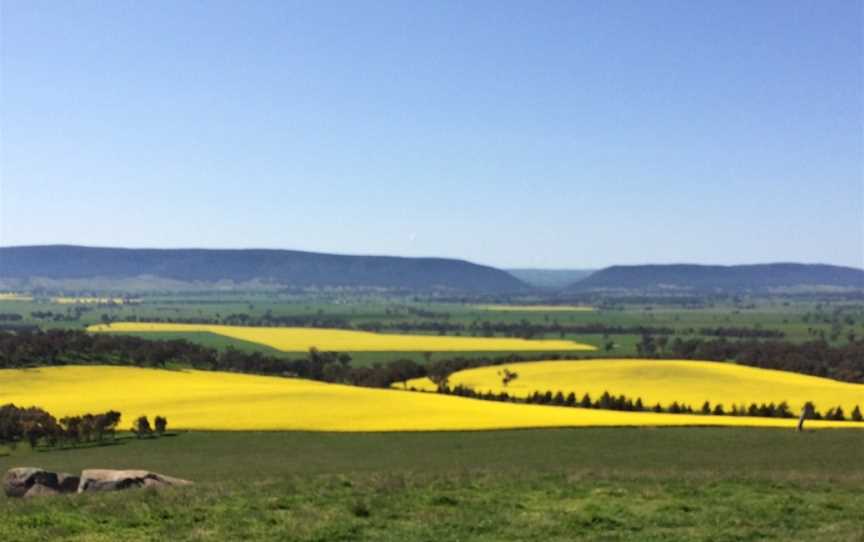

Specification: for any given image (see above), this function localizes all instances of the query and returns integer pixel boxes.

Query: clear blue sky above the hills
[0,0,864,268]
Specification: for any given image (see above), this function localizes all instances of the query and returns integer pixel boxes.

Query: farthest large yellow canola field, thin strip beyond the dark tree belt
[87,322,594,352]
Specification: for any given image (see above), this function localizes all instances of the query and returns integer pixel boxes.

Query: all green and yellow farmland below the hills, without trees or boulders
[0,292,864,541]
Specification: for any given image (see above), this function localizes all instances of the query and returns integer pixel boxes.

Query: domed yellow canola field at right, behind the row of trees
[398,359,864,417]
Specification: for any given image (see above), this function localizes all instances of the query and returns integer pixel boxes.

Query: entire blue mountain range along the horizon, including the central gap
[0,245,864,295]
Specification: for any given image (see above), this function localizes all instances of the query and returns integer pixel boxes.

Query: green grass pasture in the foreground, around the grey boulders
[0,428,864,541]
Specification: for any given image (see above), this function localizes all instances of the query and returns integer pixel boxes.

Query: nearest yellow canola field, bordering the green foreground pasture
[0,366,864,431]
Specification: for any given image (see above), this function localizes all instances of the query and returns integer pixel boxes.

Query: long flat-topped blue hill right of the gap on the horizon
[568,263,864,291]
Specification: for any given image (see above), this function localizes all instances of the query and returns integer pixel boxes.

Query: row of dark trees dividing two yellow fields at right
[438,384,864,422]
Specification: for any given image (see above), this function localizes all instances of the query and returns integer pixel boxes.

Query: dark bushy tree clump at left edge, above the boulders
[0,404,120,448]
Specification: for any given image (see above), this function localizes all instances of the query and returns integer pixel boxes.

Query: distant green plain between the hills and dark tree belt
[0,292,864,364]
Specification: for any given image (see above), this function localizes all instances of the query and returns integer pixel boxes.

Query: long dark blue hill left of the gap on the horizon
[0,245,528,292]
